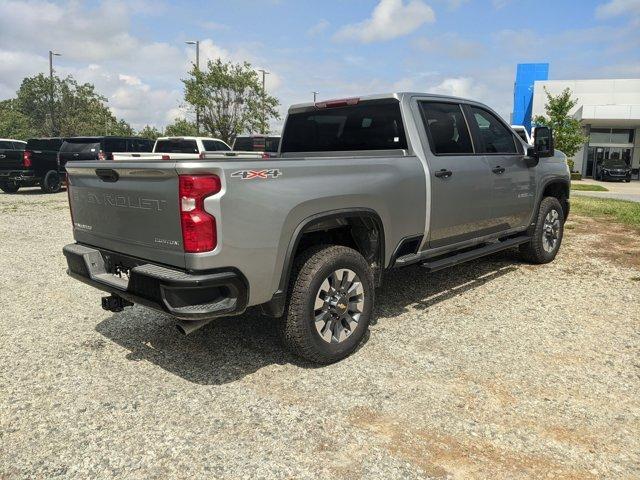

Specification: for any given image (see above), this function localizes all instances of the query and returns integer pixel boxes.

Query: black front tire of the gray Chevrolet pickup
[520,197,564,264]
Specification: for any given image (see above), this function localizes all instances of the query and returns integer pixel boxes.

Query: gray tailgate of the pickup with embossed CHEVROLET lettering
[66,161,185,268]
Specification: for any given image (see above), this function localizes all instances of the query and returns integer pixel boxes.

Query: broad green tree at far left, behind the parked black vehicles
[14,73,133,136]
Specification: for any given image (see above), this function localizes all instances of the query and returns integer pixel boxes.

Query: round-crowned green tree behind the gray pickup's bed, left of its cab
[183,59,280,144]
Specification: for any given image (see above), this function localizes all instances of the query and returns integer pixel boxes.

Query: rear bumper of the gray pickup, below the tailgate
[62,243,249,320]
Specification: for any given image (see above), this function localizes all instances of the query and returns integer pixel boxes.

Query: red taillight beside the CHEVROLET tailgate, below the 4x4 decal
[178,175,222,253]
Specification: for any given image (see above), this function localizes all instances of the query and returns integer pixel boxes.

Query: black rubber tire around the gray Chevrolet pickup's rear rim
[282,245,375,365]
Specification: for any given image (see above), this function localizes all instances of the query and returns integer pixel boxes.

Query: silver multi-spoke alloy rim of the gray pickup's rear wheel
[313,268,365,343]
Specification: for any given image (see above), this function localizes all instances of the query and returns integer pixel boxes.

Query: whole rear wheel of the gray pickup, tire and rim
[283,245,374,364]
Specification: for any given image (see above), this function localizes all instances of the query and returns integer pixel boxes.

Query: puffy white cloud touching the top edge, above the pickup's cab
[334,0,435,43]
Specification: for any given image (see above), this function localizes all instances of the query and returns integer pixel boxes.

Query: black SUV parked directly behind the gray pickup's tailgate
[58,137,154,167]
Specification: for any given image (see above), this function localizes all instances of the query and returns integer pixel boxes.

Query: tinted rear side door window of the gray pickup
[420,102,473,155]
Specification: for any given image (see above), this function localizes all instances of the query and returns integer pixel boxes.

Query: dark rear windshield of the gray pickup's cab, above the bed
[281,100,407,153]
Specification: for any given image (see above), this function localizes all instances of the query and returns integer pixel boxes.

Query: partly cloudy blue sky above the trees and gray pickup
[0,0,640,129]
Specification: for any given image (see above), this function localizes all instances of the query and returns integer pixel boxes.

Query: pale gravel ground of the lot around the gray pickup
[0,190,640,479]
